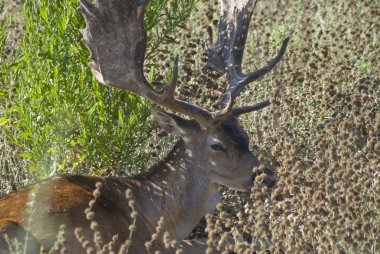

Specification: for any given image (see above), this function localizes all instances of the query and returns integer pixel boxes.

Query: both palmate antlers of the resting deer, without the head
[80,0,288,126]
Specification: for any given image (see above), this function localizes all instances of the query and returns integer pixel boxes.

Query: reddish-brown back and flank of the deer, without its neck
[0,175,141,251]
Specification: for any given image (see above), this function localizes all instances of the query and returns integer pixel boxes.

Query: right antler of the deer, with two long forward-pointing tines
[207,0,289,115]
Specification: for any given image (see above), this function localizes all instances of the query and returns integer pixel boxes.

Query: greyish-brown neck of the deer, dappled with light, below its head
[134,140,220,240]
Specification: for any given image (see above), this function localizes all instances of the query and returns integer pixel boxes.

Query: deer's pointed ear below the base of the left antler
[152,108,196,139]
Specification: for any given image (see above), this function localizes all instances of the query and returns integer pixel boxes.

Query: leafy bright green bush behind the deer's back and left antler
[1,0,199,178]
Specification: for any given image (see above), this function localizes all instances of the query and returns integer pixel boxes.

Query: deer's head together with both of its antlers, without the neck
[80,0,288,190]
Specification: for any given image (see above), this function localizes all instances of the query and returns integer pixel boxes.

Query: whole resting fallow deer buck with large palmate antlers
[0,0,289,253]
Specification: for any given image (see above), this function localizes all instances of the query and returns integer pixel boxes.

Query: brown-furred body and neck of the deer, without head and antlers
[0,135,266,253]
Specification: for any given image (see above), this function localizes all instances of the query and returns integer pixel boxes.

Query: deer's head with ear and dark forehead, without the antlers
[153,109,259,191]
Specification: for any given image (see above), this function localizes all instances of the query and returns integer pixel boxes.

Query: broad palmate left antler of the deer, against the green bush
[79,0,212,124]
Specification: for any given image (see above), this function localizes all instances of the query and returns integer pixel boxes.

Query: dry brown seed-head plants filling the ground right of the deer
[0,0,380,253]
